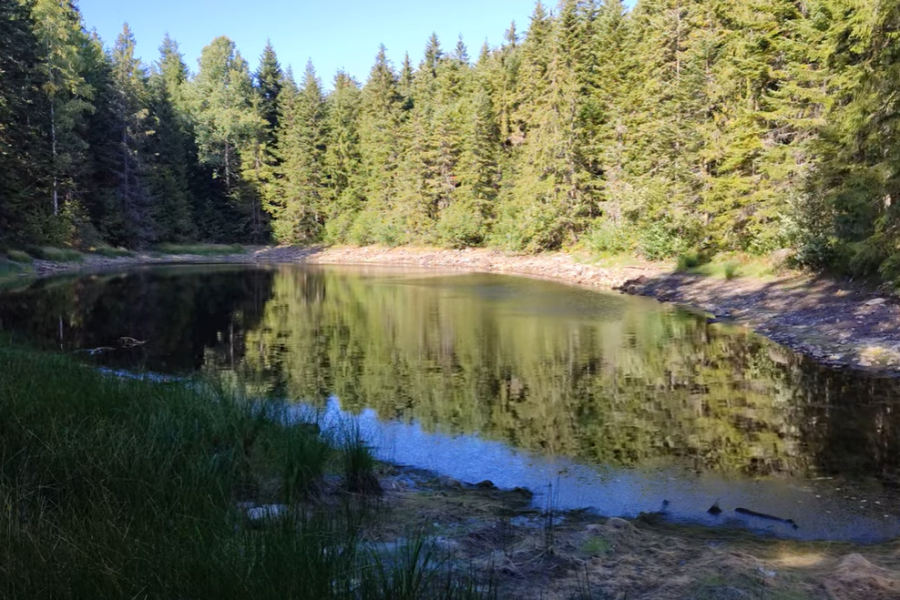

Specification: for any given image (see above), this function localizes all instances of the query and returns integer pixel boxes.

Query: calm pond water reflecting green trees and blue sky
[0,266,900,541]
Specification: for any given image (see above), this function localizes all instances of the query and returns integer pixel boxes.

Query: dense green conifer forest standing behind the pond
[0,0,900,281]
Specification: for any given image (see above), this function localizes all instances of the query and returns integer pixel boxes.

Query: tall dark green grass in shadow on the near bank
[0,341,492,600]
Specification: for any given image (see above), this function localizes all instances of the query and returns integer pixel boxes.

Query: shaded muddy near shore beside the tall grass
[366,467,900,600]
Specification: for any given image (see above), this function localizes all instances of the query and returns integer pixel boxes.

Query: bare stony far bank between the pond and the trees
[10,246,900,374]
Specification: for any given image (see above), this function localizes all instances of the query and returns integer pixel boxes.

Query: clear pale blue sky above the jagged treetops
[78,0,555,87]
